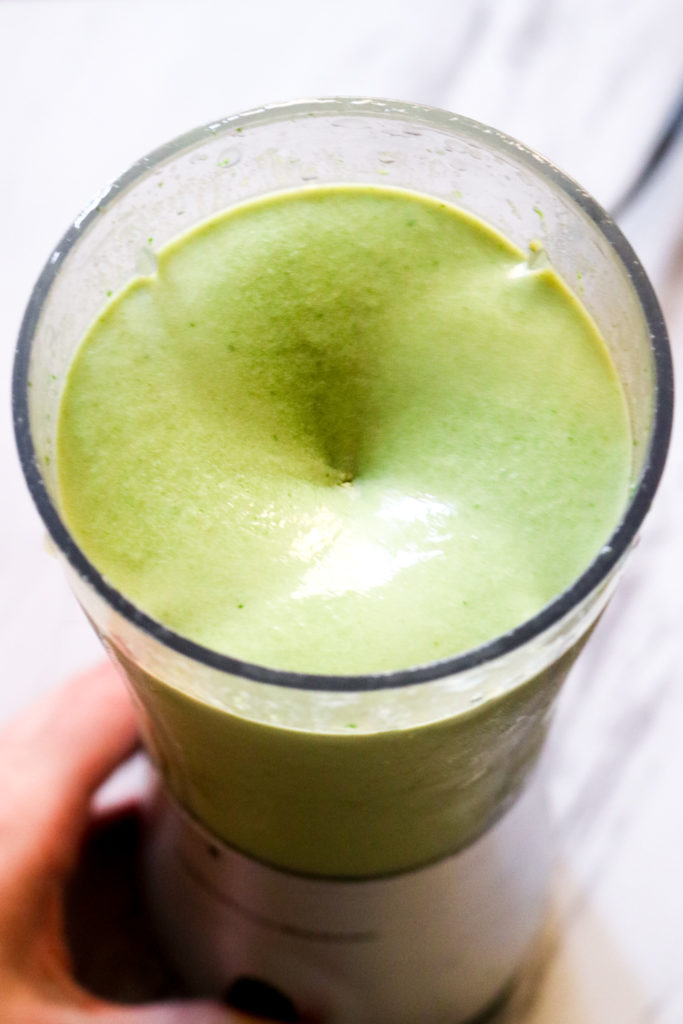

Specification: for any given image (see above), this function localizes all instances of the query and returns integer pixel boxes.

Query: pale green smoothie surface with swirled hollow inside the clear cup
[57,185,632,675]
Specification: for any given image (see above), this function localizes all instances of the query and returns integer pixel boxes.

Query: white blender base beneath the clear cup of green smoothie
[145,775,550,1024]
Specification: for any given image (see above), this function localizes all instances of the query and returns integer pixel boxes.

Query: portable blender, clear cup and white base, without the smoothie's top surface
[13,99,672,1024]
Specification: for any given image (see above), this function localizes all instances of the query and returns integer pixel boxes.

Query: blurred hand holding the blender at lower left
[0,666,256,1024]
